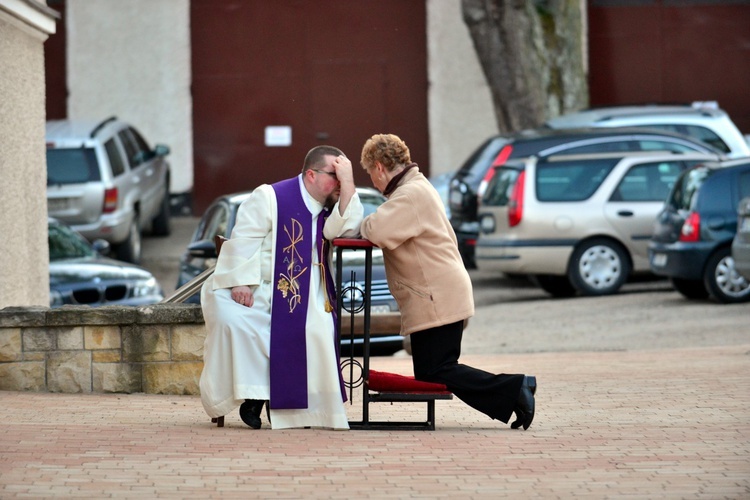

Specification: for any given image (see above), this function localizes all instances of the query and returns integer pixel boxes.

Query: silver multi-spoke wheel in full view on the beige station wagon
[568,238,630,295]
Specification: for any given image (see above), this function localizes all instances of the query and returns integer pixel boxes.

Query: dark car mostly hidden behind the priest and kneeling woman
[177,187,403,356]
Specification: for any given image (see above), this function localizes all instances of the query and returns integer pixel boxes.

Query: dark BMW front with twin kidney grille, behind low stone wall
[48,219,164,308]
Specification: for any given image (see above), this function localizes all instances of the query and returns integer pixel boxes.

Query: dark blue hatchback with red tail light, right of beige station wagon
[649,158,750,303]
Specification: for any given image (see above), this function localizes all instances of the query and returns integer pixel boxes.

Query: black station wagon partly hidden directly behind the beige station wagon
[448,128,721,268]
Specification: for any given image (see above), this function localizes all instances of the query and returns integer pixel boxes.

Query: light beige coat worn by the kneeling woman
[361,167,474,335]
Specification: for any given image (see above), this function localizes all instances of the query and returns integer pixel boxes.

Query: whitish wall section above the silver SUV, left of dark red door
[66,0,193,197]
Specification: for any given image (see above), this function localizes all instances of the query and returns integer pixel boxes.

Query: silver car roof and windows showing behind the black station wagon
[545,101,750,158]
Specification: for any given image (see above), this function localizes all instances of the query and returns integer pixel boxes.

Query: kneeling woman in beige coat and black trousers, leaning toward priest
[360,134,536,429]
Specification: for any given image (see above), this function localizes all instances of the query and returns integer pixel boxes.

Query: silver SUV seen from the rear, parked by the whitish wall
[46,117,170,263]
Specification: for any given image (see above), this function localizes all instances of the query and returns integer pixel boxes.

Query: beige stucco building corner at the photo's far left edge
[0,1,54,309]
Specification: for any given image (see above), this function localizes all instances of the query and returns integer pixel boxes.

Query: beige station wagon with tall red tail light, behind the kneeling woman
[476,152,718,297]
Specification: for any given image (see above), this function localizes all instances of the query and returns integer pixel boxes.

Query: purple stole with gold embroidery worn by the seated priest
[270,177,341,410]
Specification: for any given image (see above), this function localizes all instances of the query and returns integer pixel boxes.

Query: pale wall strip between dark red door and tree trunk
[427,0,498,177]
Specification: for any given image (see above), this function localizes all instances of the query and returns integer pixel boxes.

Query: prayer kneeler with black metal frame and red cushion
[333,238,453,431]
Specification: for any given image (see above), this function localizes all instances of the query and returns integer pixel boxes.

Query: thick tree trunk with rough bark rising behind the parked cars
[462,0,588,132]
